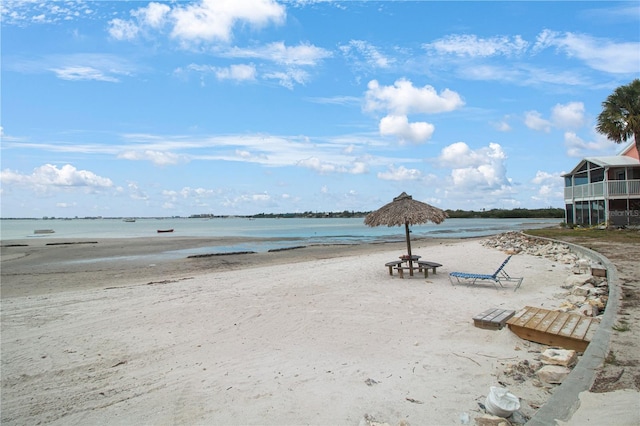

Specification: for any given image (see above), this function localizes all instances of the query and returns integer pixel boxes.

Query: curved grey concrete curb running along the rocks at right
[526,235,621,426]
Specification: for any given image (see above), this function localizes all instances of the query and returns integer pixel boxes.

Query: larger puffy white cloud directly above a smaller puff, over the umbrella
[365,79,464,115]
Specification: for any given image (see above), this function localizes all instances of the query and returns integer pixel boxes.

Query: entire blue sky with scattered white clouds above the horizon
[1,0,640,217]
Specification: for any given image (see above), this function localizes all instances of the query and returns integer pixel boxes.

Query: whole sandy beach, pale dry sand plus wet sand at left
[1,239,632,425]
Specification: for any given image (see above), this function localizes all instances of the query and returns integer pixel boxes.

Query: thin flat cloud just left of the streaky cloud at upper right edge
[425,34,529,57]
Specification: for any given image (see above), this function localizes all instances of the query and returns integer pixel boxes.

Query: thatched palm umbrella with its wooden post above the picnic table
[364,192,447,275]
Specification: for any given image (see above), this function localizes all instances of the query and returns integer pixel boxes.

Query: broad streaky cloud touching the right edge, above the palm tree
[534,30,640,74]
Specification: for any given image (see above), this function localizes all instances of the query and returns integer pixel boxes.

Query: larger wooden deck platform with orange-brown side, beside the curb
[507,306,600,352]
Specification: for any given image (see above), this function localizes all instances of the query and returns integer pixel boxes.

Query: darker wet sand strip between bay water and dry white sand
[0,233,470,299]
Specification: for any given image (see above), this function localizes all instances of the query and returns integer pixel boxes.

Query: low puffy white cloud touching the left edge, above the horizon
[0,164,113,191]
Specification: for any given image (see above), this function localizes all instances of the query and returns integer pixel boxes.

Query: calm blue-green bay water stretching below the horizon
[0,218,561,245]
